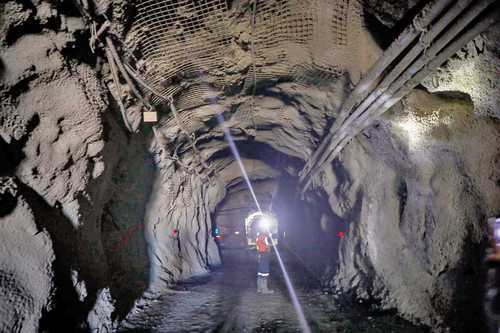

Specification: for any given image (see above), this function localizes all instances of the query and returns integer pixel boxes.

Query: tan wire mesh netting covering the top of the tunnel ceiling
[126,0,362,110]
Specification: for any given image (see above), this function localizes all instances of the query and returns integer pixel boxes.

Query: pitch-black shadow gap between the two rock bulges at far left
[0,114,91,332]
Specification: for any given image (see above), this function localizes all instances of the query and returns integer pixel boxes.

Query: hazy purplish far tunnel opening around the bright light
[213,165,347,288]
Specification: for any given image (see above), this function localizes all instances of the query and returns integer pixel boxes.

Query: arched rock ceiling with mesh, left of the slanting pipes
[106,0,380,185]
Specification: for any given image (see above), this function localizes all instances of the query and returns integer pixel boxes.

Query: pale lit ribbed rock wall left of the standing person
[145,161,224,291]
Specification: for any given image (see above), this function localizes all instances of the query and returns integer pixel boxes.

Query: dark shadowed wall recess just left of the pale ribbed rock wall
[97,131,154,320]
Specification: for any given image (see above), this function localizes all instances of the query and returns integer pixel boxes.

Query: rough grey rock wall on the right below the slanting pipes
[327,91,500,329]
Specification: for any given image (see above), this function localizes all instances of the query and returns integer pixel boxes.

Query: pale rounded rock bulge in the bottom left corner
[0,178,55,332]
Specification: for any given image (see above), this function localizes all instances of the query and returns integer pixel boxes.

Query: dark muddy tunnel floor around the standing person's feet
[118,250,427,333]
